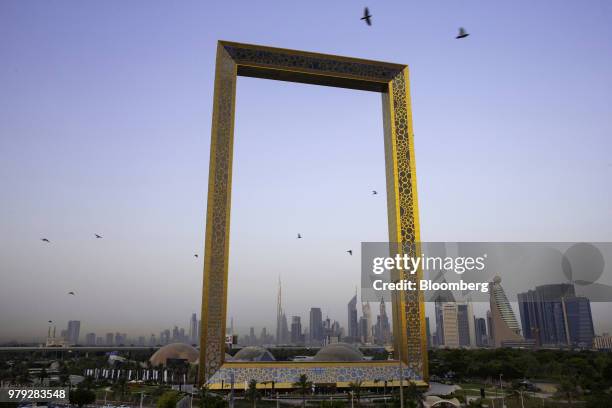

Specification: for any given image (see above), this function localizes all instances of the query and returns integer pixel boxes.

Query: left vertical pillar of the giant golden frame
[198,44,236,384]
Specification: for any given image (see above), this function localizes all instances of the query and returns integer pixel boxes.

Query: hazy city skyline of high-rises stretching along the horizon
[5,277,609,356]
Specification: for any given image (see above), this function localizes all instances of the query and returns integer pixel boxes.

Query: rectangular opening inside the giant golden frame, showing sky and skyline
[226,78,391,361]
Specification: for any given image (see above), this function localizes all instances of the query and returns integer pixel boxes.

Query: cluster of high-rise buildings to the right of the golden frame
[427,277,605,348]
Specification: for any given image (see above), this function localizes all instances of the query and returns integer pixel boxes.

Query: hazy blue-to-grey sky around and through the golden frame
[0,0,612,339]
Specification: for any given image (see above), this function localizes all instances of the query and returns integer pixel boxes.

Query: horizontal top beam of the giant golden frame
[219,41,406,92]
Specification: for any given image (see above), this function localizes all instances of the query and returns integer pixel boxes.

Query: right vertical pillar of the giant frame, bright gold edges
[382,68,428,381]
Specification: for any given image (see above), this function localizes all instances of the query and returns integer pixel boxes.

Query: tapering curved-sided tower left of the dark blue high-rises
[489,276,524,347]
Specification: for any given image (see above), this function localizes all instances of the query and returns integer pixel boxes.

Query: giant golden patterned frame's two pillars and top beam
[199,41,428,384]
